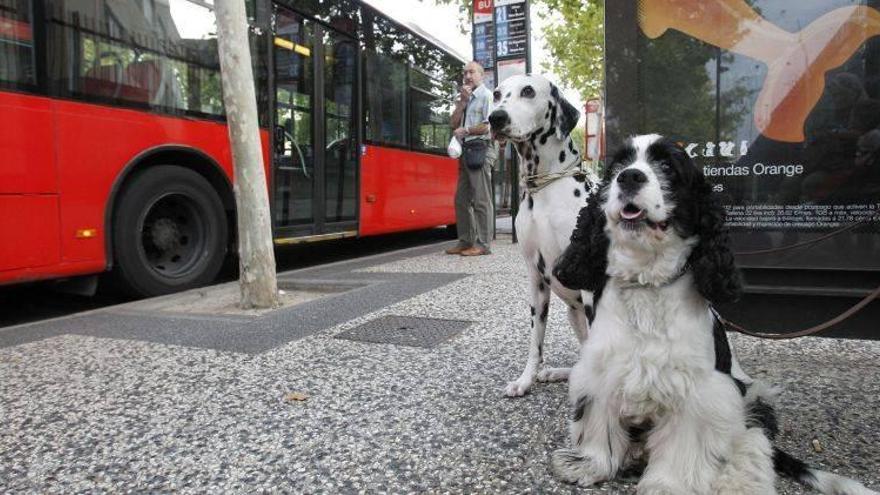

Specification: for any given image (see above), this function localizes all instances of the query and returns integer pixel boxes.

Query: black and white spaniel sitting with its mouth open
[552,135,874,495]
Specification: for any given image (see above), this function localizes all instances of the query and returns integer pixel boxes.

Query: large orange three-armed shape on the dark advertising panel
[639,0,880,143]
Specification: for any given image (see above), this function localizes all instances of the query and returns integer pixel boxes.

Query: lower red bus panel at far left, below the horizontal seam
[0,194,61,272]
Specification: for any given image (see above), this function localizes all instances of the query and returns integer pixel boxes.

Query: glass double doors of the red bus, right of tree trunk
[272,5,358,241]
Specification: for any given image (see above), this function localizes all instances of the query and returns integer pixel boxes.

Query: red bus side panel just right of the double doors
[359,145,458,235]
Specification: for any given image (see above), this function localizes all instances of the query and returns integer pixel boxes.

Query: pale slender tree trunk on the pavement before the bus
[214,0,278,309]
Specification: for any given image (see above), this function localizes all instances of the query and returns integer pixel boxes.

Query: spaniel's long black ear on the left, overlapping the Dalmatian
[553,187,609,294]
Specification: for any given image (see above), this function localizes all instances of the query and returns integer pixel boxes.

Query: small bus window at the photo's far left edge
[0,0,36,86]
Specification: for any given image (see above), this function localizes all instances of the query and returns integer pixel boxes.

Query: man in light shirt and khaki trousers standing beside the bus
[446,62,498,256]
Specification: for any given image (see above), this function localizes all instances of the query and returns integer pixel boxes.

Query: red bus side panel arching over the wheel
[55,101,232,262]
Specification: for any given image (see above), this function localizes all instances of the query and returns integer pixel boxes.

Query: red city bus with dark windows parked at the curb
[0,0,464,296]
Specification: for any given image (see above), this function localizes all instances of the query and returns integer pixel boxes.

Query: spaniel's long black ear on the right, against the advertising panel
[688,174,742,304]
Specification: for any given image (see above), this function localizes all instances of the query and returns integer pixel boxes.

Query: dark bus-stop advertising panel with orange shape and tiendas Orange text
[606,0,880,269]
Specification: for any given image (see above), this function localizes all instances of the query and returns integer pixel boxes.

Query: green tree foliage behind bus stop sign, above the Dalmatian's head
[422,0,605,100]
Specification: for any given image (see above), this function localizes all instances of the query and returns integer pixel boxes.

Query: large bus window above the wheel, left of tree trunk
[47,0,223,115]
